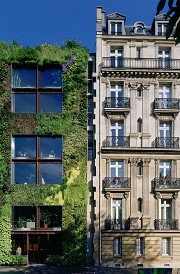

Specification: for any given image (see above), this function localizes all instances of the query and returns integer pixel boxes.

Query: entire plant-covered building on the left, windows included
[0,41,88,264]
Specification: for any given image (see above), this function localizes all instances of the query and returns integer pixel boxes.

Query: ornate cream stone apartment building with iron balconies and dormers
[88,7,180,269]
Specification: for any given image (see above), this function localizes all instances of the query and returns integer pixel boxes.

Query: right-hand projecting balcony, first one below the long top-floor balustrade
[154,98,180,114]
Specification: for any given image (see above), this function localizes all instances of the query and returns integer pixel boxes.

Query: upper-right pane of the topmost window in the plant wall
[40,69,62,87]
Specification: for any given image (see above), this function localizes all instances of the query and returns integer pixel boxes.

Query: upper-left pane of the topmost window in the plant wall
[12,69,36,87]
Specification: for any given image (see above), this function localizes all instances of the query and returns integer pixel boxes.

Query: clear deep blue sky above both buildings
[0,0,169,52]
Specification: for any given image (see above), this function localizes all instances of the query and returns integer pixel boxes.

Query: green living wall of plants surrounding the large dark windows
[0,41,89,265]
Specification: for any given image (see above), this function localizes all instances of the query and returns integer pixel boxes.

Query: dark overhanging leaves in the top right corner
[156,0,180,45]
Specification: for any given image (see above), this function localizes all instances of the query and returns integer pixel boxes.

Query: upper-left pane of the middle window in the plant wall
[12,136,36,158]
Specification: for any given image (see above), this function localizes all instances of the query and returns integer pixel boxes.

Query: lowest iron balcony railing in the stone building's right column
[154,219,178,230]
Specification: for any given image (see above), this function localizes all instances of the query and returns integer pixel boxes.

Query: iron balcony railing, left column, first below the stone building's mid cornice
[103,176,131,188]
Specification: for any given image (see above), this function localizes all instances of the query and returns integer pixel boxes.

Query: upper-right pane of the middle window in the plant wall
[40,137,62,158]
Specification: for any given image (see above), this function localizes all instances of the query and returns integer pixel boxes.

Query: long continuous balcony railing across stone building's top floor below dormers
[102,56,180,69]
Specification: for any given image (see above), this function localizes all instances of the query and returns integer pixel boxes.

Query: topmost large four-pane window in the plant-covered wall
[12,67,62,114]
